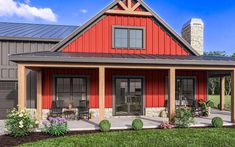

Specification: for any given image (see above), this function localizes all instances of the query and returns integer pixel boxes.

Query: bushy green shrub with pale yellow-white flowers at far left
[5,108,39,137]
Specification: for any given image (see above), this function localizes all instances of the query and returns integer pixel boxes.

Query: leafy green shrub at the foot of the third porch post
[173,107,194,128]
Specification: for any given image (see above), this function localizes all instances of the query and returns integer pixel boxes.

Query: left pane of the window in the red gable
[114,29,128,48]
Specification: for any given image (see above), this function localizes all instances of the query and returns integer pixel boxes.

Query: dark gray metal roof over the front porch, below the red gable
[9,51,235,66]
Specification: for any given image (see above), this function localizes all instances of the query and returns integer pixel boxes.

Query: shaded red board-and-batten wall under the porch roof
[43,69,207,109]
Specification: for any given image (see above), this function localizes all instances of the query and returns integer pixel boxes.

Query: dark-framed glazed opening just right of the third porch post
[176,78,195,106]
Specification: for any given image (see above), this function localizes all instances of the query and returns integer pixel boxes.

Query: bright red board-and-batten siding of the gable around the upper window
[62,15,189,55]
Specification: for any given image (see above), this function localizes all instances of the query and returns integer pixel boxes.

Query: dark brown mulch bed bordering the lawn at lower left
[0,131,100,147]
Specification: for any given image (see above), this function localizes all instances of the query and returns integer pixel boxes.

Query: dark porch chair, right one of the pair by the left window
[77,100,91,120]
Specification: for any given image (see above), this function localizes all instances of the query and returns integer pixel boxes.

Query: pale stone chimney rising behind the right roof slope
[181,18,204,55]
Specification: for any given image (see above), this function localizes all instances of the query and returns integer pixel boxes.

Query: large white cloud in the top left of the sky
[0,0,57,22]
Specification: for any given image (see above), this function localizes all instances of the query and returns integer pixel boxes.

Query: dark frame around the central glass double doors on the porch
[112,75,145,116]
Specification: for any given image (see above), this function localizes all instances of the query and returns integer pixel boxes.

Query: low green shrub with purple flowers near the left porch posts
[42,117,68,136]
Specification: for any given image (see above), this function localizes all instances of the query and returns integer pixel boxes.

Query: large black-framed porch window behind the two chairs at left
[55,77,89,108]
